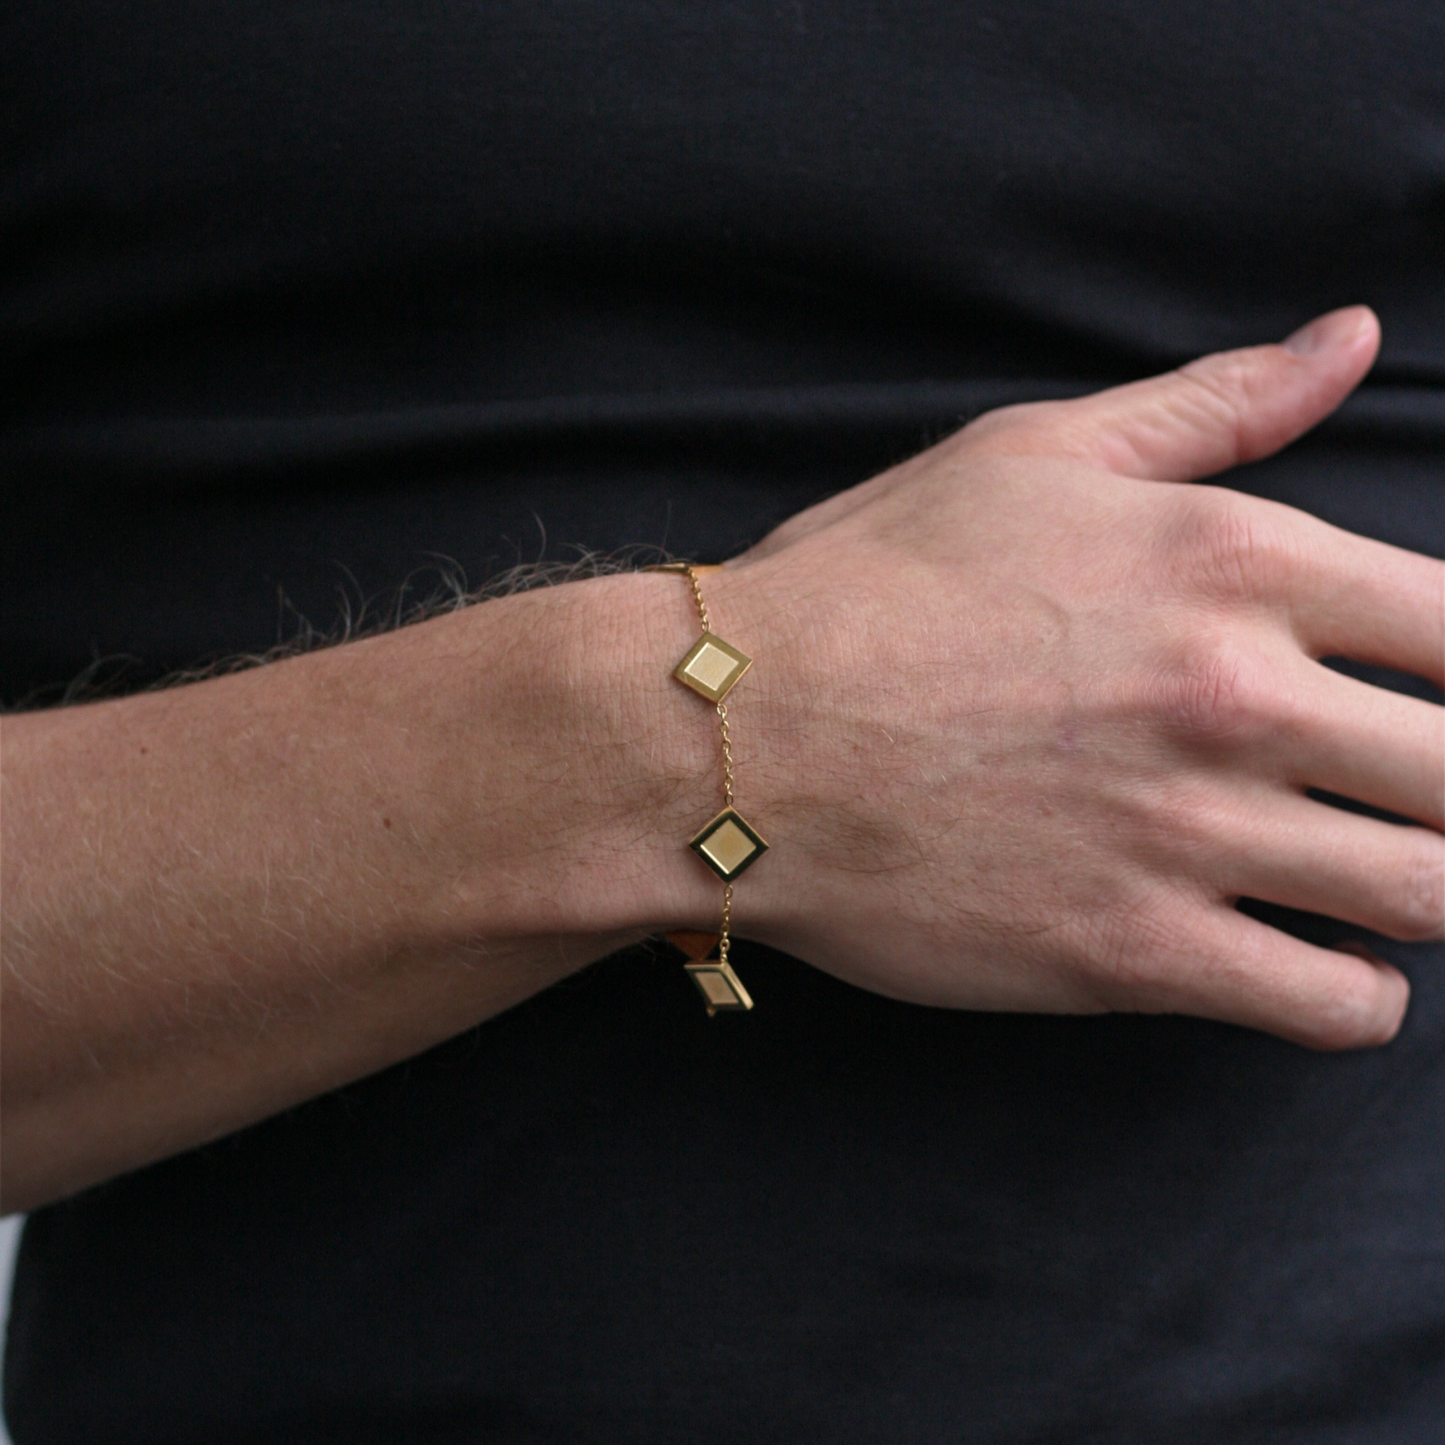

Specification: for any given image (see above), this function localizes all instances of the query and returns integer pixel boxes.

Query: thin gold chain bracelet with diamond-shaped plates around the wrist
[647,562,767,1016]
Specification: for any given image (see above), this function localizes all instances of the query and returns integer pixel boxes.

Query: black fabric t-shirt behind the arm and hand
[0,0,1445,1445]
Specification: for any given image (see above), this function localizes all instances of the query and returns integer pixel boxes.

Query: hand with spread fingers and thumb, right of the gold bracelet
[709,308,1445,1048]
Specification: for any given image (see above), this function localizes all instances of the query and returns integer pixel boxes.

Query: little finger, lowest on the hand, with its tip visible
[1144,905,1410,1049]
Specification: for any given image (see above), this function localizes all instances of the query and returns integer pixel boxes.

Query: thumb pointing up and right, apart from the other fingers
[964,306,1380,481]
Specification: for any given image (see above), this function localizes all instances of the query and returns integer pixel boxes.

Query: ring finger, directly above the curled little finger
[1209,796,1445,942]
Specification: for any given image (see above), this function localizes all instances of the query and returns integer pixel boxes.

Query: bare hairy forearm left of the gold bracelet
[3,577,715,1209]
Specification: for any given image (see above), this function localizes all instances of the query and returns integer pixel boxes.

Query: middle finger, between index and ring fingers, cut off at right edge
[1289,668,1445,831]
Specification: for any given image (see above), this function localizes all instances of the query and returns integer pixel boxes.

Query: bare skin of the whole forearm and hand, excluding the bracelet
[3,308,1445,1209]
